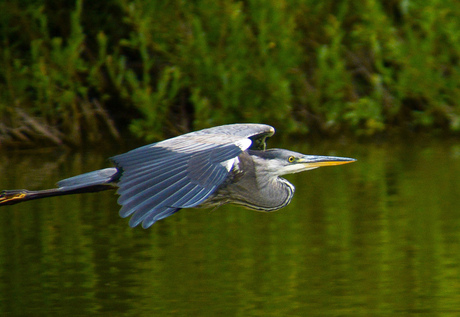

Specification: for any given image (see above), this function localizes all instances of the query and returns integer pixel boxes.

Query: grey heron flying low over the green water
[0,123,356,229]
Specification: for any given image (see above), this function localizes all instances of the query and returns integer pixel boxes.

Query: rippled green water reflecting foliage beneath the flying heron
[0,140,460,316]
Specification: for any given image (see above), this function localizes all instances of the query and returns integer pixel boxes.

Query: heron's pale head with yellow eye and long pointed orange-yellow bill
[251,149,356,176]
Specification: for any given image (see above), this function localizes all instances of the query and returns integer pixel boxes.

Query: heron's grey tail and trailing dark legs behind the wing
[0,167,119,206]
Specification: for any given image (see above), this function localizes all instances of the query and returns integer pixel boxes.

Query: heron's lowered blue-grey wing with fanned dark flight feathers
[112,124,274,228]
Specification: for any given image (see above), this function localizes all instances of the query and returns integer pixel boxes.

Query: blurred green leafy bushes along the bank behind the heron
[0,0,460,146]
